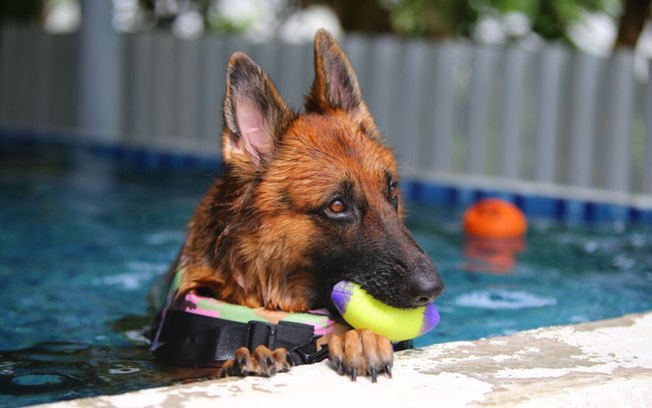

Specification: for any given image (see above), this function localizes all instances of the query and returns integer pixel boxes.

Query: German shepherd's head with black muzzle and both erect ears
[222,30,443,308]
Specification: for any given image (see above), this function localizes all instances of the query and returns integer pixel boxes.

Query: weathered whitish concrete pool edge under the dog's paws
[43,312,652,408]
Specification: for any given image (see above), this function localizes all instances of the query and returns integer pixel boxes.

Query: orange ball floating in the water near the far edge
[464,198,527,238]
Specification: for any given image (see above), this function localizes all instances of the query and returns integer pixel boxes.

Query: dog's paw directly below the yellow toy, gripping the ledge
[328,330,394,382]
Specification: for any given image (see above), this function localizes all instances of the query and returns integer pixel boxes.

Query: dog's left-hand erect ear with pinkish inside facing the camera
[222,52,293,170]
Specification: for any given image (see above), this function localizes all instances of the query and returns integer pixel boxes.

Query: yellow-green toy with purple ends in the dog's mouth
[331,281,439,342]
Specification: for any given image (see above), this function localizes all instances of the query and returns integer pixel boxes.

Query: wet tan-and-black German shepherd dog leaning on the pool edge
[171,30,443,380]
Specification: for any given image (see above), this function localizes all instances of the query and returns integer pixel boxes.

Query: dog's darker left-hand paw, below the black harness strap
[219,346,291,377]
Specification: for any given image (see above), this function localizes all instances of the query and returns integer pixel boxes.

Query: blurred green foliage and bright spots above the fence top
[0,0,652,56]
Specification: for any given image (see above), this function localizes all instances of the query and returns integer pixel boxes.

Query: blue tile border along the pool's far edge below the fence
[5,129,652,226]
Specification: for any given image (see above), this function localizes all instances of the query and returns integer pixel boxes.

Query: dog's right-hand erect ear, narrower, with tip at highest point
[306,29,368,117]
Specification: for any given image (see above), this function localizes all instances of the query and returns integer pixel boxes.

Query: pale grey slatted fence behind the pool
[0,26,652,200]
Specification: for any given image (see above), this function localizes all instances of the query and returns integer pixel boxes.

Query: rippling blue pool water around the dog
[0,139,652,406]
